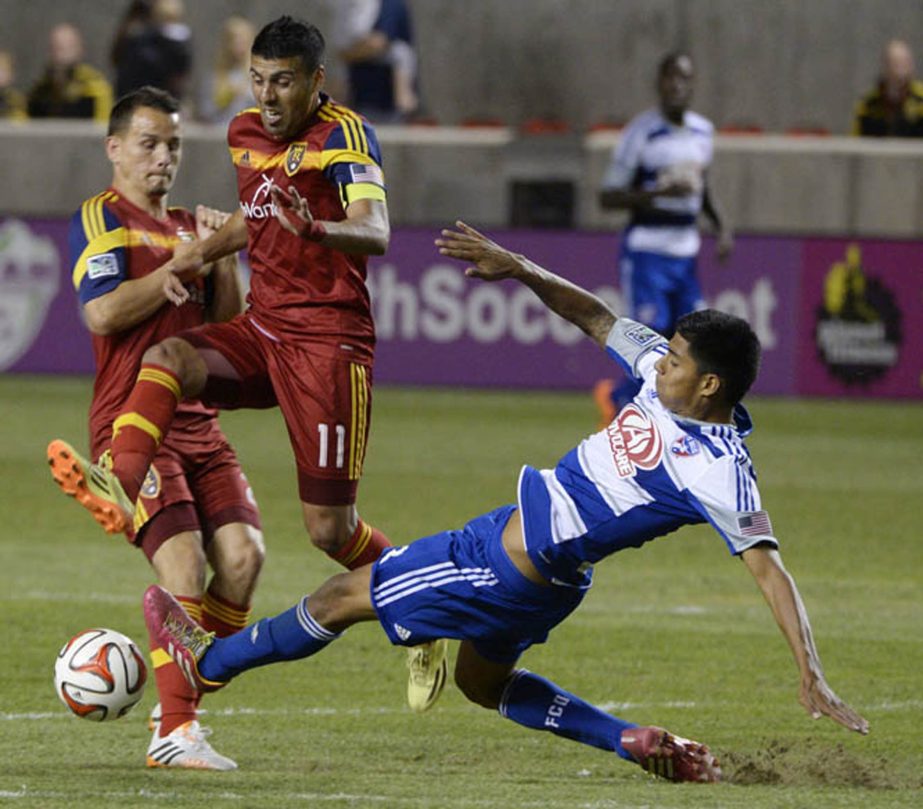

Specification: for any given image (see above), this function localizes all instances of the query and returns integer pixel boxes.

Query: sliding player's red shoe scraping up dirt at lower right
[621,727,721,783]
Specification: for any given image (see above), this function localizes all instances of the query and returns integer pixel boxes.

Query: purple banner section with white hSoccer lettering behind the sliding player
[369,230,800,394]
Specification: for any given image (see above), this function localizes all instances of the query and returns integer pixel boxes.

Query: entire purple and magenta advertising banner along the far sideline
[0,219,923,397]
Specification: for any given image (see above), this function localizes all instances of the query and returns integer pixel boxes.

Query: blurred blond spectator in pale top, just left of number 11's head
[200,16,256,124]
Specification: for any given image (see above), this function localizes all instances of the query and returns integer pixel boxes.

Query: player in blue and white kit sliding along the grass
[145,223,868,781]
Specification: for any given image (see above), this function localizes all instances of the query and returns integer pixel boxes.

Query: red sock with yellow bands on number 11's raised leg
[111,363,182,501]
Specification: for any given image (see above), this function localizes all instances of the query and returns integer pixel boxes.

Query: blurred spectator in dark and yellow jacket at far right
[853,39,923,138]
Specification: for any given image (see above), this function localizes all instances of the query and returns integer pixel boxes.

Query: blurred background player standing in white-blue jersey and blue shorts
[596,53,733,416]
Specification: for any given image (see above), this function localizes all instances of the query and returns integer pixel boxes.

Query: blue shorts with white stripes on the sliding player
[371,505,584,663]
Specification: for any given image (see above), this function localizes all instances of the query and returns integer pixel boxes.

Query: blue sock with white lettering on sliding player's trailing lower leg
[500,669,637,761]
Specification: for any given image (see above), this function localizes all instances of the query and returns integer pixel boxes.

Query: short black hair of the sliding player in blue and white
[676,309,760,405]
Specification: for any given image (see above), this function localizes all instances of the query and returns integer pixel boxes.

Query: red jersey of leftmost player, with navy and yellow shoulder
[69,188,220,458]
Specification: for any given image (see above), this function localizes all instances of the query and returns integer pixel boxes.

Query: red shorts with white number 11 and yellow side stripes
[178,314,372,506]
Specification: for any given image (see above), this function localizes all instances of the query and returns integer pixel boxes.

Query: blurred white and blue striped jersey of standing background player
[603,109,715,258]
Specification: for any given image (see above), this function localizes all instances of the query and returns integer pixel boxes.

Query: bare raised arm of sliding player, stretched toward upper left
[436,221,617,346]
